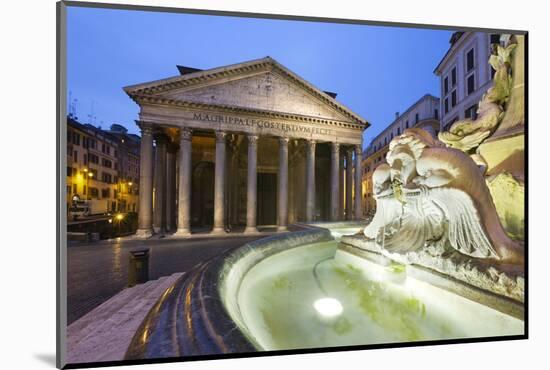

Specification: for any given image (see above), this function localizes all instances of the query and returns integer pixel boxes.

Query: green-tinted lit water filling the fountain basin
[238,242,523,350]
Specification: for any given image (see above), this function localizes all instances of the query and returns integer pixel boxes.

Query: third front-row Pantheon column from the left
[212,131,227,234]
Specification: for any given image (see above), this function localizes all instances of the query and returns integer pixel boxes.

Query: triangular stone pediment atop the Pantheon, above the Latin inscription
[125,58,368,124]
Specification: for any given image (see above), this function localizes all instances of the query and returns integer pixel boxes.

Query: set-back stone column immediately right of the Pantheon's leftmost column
[153,134,168,234]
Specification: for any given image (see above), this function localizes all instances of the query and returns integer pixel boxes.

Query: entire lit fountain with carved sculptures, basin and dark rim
[126,36,525,360]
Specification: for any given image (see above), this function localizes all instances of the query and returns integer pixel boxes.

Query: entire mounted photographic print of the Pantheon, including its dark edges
[58,1,528,368]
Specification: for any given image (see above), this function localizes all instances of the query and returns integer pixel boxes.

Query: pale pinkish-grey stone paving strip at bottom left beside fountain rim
[67,273,183,363]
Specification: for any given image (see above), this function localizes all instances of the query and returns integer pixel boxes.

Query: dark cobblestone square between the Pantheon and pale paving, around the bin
[67,235,264,324]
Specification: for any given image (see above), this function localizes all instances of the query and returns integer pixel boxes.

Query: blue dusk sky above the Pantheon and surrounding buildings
[67,7,452,147]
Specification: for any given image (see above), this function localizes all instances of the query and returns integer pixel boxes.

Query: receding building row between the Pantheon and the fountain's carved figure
[361,94,440,215]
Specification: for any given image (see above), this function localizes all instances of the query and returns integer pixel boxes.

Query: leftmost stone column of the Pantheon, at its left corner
[136,125,153,238]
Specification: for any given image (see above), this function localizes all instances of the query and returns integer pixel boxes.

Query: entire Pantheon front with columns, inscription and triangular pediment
[124,57,369,237]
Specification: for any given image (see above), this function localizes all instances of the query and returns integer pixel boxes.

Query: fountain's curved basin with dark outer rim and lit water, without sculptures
[126,224,524,359]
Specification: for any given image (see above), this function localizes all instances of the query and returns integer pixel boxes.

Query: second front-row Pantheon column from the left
[176,128,192,236]
